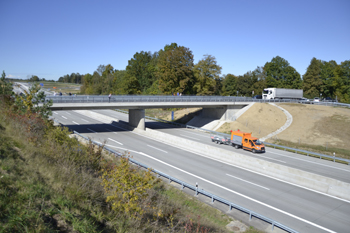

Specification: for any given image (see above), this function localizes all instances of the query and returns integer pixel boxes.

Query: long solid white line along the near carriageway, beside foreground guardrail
[139,152,336,233]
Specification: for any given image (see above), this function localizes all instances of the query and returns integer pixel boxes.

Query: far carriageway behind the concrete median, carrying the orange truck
[94,110,350,183]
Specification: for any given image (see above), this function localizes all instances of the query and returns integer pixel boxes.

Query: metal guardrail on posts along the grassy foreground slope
[74,131,298,233]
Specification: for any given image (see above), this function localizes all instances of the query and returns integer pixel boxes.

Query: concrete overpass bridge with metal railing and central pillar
[46,95,291,129]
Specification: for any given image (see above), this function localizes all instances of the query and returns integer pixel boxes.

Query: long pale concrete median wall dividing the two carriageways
[73,110,350,200]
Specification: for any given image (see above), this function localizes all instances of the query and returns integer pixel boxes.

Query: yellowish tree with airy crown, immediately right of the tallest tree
[193,54,222,95]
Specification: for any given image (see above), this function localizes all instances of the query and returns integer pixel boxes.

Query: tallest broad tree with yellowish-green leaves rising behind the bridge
[156,44,194,94]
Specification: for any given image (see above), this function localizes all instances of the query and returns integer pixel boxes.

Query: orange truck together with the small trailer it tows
[210,129,265,153]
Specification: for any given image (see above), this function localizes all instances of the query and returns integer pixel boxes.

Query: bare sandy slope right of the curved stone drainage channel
[277,104,350,149]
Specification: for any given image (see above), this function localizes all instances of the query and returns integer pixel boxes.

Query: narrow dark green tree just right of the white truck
[303,58,322,98]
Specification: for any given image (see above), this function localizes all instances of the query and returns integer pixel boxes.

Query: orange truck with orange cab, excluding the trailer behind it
[230,130,265,153]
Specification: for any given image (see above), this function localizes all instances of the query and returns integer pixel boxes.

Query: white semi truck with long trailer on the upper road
[262,88,303,100]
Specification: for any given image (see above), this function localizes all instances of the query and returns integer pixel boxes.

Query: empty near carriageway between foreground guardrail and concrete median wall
[54,111,350,232]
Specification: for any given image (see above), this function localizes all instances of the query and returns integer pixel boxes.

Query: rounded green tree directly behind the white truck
[264,56,302,89]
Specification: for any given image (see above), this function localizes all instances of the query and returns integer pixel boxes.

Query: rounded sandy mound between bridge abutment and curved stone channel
[217,103,287,138]
